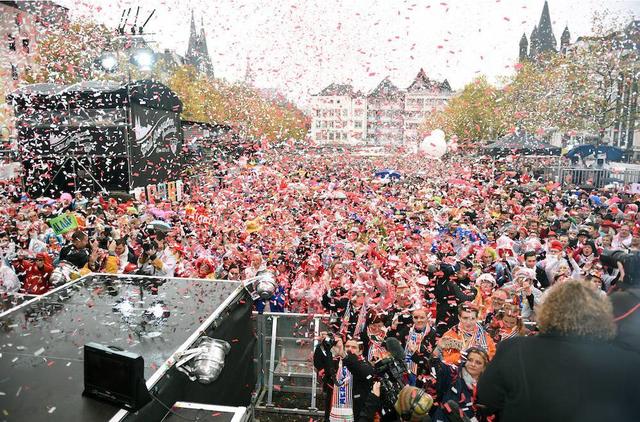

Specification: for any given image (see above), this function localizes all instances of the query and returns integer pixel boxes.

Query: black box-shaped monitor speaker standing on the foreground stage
[82,343,151,411]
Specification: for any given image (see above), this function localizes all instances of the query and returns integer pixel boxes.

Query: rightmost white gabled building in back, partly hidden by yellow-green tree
[402,69,453,143]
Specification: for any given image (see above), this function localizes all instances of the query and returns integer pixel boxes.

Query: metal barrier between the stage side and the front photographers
[254,312,329,416]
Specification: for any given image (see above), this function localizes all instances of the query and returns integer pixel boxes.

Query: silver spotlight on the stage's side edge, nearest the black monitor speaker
[176,336,231,384]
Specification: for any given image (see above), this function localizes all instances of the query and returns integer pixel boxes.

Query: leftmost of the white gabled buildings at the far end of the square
[311,84,367,144]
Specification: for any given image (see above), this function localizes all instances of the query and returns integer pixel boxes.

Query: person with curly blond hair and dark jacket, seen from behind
[478,280,640,422]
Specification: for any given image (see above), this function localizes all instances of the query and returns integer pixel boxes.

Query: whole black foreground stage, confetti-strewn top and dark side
[0,274,255,422]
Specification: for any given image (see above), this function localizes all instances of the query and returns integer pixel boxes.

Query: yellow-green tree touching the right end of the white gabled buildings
[422,76,506,142]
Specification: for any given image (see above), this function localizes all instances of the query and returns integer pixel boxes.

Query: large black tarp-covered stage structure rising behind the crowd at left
[7,80,183,196]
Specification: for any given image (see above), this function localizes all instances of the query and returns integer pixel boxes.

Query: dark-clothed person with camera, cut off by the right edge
[600,251,640,353]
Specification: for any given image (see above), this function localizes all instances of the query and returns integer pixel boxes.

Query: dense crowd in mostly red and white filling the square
[0,150,640,421]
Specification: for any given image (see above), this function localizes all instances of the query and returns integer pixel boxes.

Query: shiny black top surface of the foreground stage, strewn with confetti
[0,275,239,422]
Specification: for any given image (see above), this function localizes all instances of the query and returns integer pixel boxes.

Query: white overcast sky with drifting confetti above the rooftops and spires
[59,0,640,104]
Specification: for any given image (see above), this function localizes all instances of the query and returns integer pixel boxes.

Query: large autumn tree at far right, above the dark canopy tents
[502,12,638,142]
